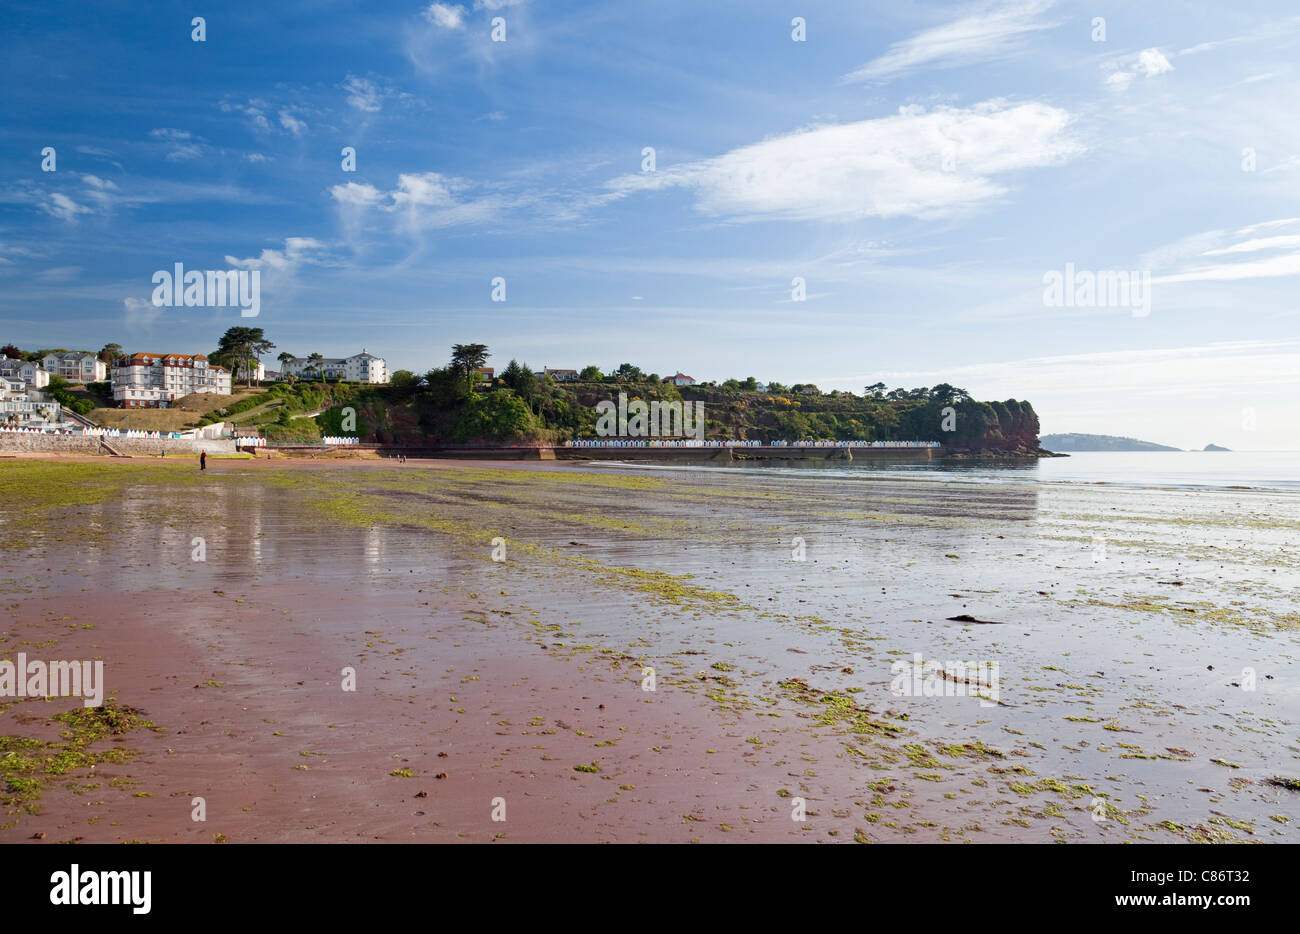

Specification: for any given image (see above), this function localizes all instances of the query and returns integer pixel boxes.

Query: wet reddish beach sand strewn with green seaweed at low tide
[0,458,1300,843]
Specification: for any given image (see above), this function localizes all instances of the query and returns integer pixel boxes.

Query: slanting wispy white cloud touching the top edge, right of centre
[842,0,1056,82]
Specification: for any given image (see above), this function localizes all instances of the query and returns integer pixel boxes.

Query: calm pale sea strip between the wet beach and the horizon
[605,451,1300,492]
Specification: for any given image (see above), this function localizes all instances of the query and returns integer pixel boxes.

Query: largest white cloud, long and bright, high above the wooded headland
[608,100,1083,221]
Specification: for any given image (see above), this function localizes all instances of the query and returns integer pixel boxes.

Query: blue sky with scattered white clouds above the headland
[0,0,1300,450]
